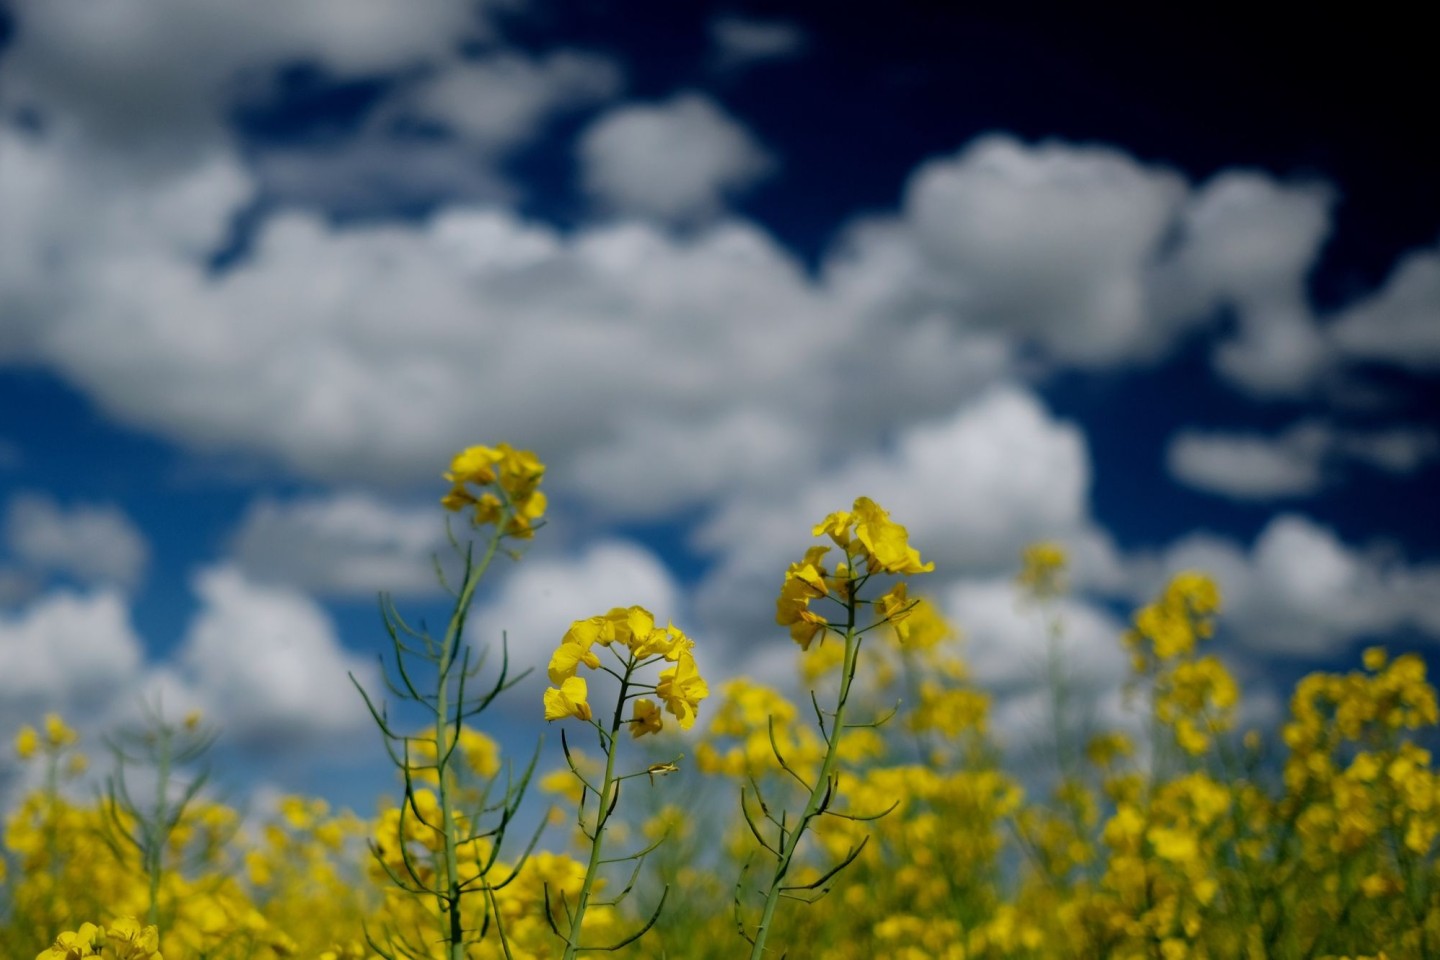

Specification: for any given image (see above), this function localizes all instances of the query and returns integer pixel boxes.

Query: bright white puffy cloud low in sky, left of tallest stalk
[177,567,379,746]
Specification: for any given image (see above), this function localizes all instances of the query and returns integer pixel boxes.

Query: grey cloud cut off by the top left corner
[0,0,491,153]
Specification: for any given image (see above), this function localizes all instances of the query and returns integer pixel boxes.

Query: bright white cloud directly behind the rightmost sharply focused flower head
[696,387,1125,667]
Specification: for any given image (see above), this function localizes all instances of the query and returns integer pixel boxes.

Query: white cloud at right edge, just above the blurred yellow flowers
[1140,514,1440,656]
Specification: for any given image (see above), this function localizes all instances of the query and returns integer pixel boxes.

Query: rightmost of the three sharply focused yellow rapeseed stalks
[736,497,935,960]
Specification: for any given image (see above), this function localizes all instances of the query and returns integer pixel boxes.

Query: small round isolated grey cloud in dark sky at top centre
[579,94,775,220]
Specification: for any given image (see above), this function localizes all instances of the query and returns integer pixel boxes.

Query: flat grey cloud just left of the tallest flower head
[232,492,449,597]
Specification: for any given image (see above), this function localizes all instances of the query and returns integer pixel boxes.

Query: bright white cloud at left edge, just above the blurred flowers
[0,590,143,702]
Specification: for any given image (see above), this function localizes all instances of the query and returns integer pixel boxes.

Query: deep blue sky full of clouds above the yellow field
[0,0,1440,806]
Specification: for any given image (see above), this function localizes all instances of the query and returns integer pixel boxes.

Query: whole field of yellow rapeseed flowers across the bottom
[0,445,1440,960]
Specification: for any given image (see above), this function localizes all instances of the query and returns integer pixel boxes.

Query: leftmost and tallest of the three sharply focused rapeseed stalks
[350,443,546,960]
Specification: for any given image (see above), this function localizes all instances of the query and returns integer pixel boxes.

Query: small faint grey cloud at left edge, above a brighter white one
[4,494,150,589]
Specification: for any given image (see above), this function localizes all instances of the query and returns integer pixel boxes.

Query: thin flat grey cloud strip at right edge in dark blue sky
[1165,420,1440,499]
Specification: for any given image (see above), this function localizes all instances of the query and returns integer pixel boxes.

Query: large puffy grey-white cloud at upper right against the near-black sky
[828,135,1185,366]
